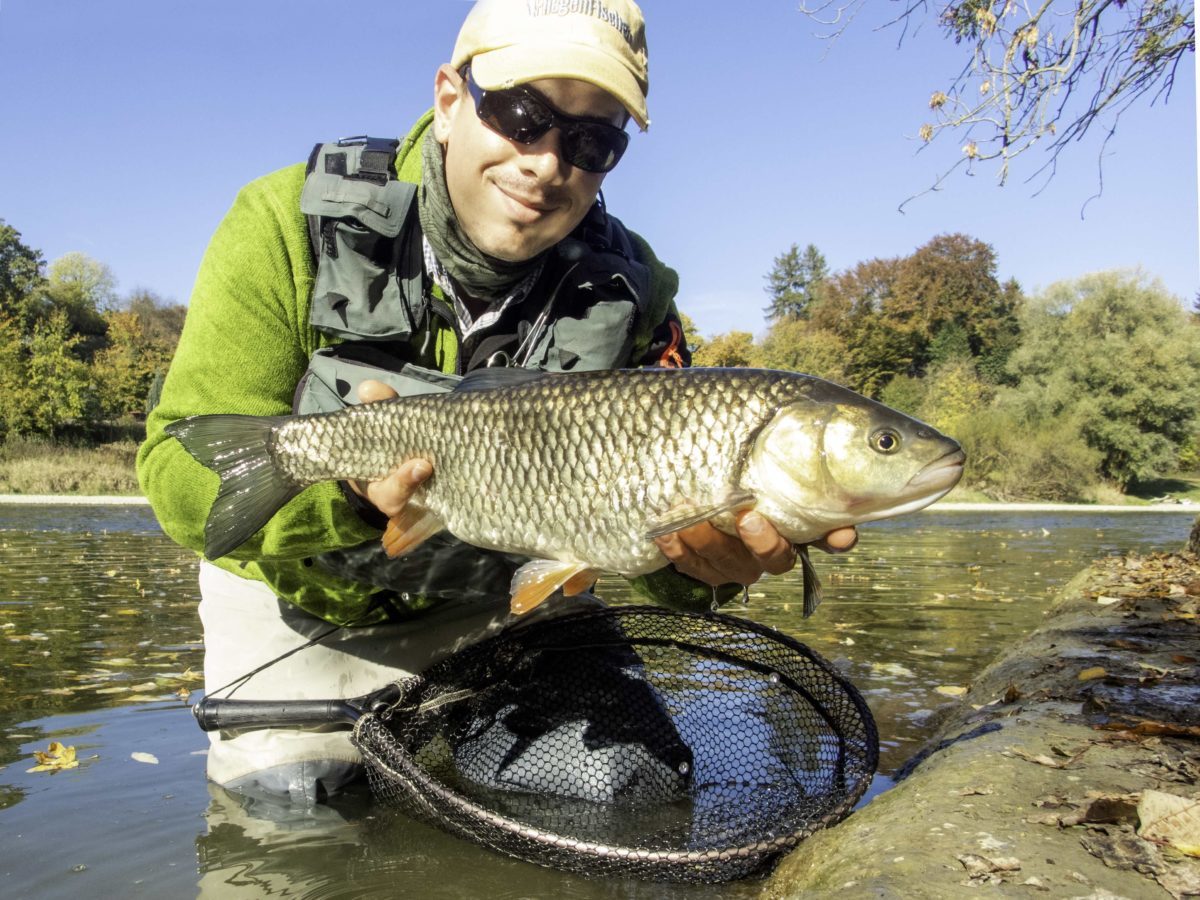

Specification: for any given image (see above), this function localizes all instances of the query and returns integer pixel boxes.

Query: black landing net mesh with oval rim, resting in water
[354,607,878,882]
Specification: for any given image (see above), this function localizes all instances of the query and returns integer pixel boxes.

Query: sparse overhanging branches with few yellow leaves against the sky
[802,0,1195,196]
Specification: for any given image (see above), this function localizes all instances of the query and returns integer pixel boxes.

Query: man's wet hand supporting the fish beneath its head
[654,510,858,587]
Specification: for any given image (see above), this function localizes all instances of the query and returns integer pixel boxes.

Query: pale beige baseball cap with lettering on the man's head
[450,0,650,131]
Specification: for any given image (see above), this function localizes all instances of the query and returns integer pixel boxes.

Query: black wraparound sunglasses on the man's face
[463,67,629,172]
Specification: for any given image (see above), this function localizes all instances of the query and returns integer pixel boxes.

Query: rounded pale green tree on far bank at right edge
[1009,272,1200,490]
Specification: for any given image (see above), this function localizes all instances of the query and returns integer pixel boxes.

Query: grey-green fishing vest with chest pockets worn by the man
[294,137,668,413]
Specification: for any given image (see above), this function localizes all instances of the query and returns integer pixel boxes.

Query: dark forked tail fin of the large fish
[166,415,305,559]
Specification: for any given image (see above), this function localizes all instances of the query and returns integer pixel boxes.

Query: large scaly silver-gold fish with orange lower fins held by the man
[167,368,964,616]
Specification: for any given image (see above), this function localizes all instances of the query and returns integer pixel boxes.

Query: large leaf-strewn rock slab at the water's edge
[763,532,1200,900]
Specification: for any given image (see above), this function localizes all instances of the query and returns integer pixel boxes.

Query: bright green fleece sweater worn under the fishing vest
[137,113,710,624]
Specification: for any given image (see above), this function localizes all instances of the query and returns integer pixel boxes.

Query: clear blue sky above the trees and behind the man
[0,0,1200,335]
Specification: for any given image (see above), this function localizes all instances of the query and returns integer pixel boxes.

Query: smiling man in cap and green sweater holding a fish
[138,0,854,803]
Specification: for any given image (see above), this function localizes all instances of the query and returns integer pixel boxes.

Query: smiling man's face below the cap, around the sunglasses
[433,66,625,262]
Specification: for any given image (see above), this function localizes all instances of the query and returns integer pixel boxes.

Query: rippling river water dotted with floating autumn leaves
[0,506,1194,900]
